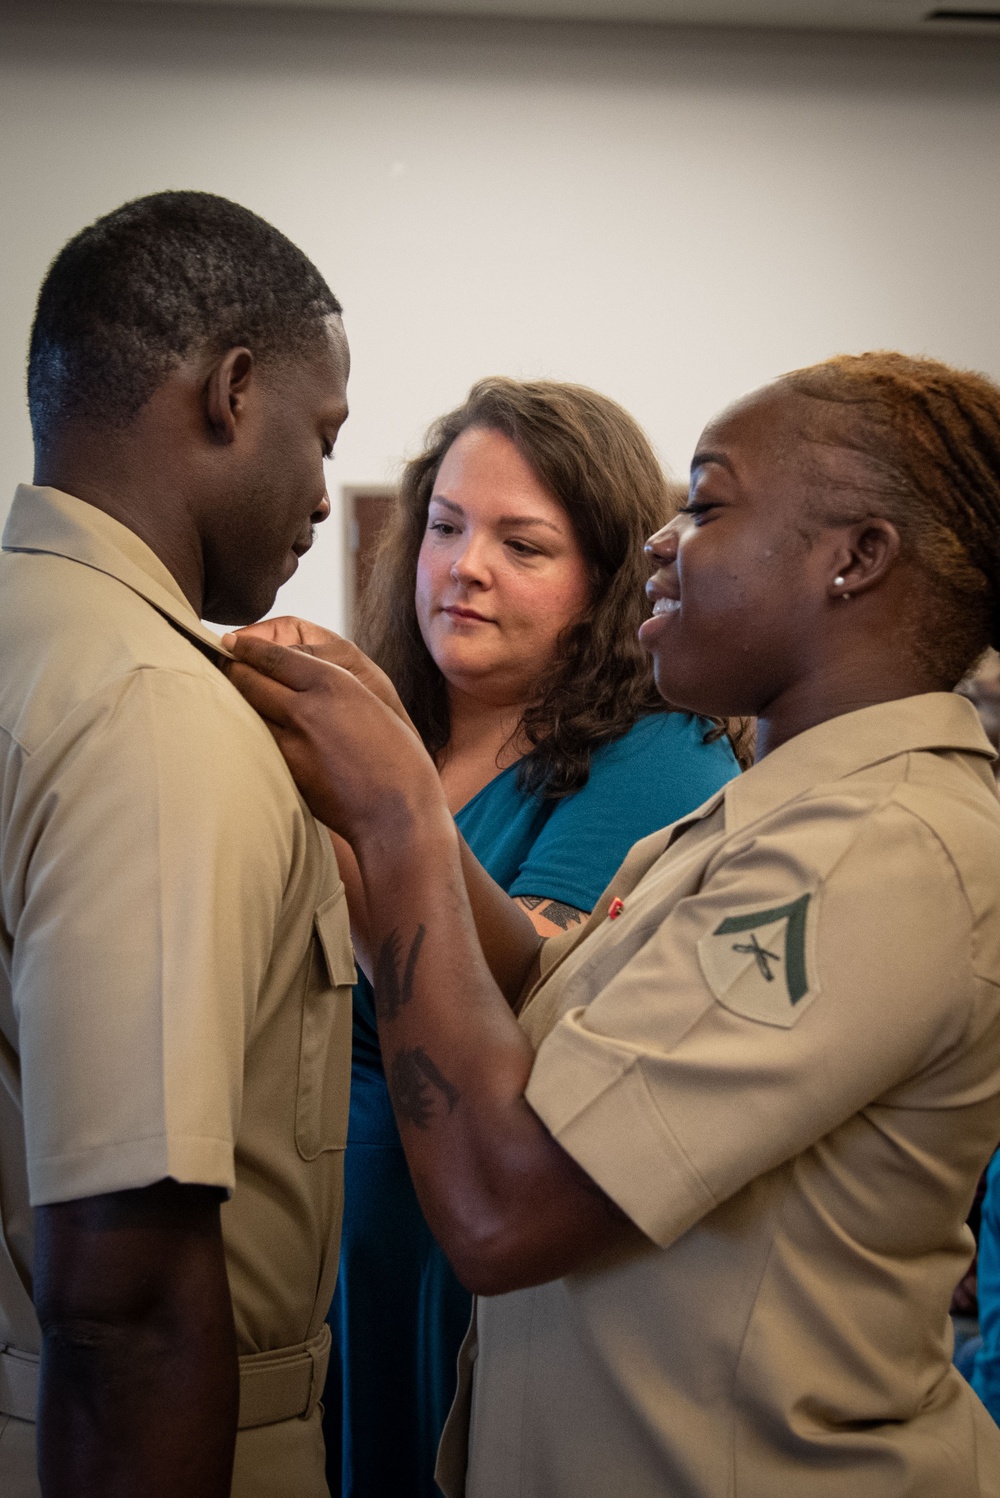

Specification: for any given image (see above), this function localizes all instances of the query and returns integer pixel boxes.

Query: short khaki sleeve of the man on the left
[3,670,295,1204]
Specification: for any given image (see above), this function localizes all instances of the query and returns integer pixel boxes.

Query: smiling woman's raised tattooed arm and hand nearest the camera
[231,638,636,1294]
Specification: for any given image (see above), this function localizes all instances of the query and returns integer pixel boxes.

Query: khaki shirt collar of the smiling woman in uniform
[723,692,996,833]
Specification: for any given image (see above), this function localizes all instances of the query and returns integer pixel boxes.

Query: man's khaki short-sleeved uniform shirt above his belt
[0,487,353,1372]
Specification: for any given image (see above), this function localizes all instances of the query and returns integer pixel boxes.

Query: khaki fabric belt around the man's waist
[0,1326,329,1431]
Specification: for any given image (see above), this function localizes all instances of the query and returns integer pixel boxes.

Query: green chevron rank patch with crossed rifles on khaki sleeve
[698,894,819,1029]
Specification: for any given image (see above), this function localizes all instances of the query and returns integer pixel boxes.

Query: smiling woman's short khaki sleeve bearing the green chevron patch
[527,803,997,1246]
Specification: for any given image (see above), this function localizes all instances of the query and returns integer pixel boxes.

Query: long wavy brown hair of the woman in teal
[356,376,742,798]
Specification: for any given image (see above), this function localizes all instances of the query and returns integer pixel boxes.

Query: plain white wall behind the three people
[0,0,1000,626]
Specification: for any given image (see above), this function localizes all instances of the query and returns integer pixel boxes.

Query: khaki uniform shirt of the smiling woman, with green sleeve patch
[442,694,1000,1498]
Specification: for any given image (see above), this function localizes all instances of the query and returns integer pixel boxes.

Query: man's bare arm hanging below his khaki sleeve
[34,1180,240,1498]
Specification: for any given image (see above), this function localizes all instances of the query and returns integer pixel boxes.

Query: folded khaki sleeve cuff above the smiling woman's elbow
[525,1010,719,1248]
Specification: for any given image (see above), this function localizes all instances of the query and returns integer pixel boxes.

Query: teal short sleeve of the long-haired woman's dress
[509,713,740,911]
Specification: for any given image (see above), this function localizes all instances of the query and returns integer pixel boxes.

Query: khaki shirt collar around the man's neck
[3,484,232,659]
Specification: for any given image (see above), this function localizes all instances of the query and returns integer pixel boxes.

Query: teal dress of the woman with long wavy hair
[323,713,738,1498]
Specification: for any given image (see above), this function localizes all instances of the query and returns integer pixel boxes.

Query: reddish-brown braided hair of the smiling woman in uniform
[783,352,1000,686]
